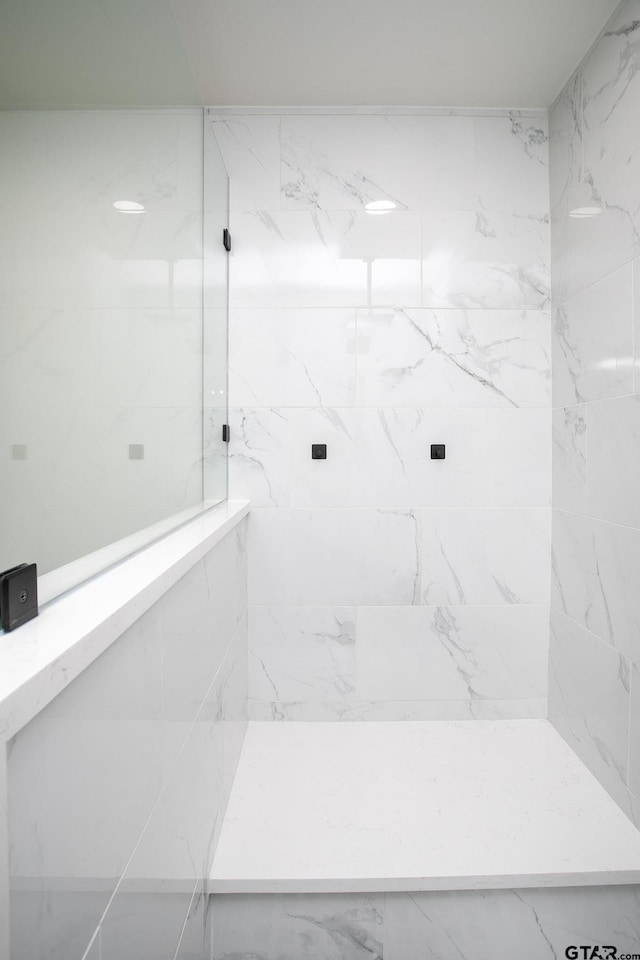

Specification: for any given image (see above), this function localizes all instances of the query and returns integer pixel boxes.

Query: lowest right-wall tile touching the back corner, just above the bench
[549,610,631,784]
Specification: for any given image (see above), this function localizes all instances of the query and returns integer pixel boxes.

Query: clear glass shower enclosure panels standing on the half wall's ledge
[0,109,228,574]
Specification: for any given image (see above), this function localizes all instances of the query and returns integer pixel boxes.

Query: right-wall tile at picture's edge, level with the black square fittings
[587,395,640,527]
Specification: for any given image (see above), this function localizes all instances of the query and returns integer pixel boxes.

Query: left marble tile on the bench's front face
[212,894,384,960]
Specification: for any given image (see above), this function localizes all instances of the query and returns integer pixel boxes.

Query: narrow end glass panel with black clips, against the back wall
[203,116,229,503]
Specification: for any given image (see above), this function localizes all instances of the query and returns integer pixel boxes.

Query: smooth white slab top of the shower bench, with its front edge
[211,720,640,893]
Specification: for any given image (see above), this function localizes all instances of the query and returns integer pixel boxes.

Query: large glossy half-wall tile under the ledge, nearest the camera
[8,611,163,960]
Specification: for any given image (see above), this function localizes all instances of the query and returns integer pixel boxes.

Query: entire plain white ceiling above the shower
[0,0,620,107]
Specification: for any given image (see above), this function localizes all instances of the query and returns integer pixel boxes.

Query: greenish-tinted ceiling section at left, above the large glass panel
[0,0,201,107]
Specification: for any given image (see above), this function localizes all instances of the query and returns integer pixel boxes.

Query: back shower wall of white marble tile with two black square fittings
[212,113,551,720]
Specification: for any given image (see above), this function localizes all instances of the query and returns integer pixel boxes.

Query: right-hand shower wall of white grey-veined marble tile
[549,0,640,823]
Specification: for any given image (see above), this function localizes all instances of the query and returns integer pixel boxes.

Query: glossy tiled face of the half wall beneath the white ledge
[8,520,247,960]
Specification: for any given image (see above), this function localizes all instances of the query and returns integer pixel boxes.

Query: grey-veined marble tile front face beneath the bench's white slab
[210,886,640,960]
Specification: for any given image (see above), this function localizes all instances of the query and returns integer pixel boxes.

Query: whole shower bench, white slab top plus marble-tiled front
[210,720,640,960]
